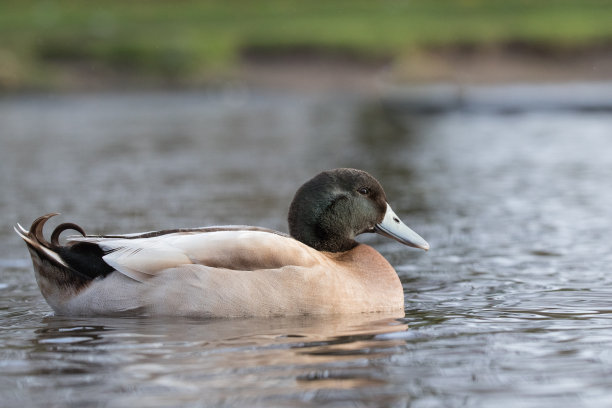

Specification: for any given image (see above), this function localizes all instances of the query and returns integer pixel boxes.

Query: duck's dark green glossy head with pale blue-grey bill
[289,169,429,252]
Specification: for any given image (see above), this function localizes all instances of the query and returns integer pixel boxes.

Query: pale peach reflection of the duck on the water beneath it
[30,313,408,381]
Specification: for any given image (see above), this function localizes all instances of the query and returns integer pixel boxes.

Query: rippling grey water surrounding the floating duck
[0,87,612,408]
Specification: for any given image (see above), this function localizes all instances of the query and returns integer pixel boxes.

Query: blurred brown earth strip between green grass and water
[0,42,612,94]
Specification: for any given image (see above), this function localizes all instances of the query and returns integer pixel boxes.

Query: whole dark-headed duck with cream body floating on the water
[15,168,429,318]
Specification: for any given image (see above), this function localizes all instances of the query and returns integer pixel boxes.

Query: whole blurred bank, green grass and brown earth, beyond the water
[0,0,612,91]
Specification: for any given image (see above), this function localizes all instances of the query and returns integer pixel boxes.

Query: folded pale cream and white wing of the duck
[68,227,320,282]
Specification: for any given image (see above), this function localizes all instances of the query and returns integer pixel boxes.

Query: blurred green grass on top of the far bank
[0,0,612,89]
